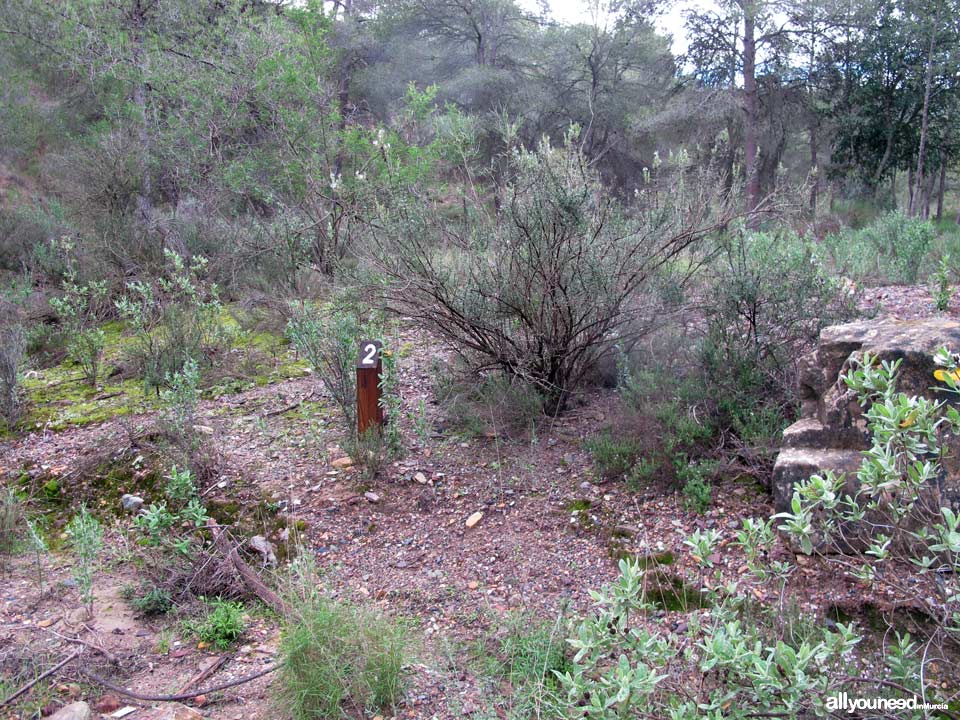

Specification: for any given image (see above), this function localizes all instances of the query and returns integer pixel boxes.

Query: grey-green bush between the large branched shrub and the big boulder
[699,232,855,462]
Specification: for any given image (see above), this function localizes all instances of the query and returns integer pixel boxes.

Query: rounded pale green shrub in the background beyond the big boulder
[824,211,935,285]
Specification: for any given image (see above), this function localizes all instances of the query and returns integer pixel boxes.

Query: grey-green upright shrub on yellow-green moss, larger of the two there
[116,250,233,392]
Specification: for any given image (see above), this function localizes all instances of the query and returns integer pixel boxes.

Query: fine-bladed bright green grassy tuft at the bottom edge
[277,560,409,720]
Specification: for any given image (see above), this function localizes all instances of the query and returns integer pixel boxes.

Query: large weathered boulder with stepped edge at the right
[771,318,960,512]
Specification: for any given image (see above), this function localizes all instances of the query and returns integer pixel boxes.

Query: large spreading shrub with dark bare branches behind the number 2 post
[371,137,733,409]
